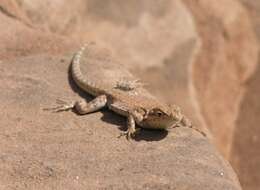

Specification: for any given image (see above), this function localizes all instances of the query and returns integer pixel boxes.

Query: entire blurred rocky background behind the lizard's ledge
[0,0,260,190]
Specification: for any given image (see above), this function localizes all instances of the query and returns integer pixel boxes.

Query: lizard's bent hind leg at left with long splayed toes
[45,95,107,115]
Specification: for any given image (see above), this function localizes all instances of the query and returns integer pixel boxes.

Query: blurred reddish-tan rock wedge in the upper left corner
[0,1,75,60]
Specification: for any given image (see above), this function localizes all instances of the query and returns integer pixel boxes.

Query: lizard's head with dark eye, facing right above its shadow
[142,106,183,129]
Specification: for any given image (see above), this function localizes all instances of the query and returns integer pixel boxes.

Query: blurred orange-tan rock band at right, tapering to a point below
[184,0,258,158]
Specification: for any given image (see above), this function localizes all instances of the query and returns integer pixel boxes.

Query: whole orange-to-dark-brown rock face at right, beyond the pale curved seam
[182,0,260,190]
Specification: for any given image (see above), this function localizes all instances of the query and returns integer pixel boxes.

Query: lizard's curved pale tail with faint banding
[71,42,102,96]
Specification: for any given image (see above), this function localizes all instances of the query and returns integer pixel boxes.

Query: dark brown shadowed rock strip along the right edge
[230,0,260,190]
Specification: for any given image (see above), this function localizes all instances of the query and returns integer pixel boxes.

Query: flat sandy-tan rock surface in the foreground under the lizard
[0,54,240,190]
